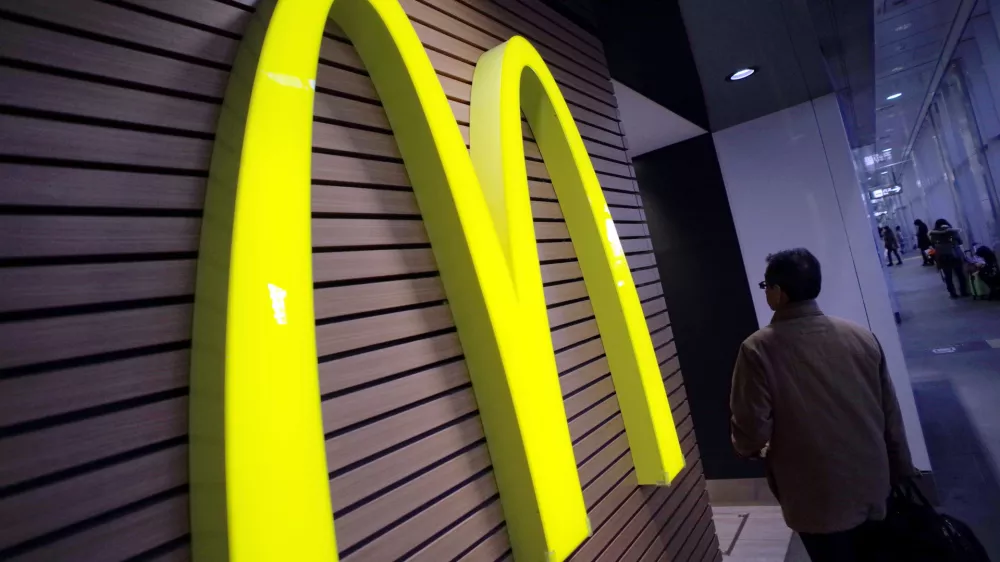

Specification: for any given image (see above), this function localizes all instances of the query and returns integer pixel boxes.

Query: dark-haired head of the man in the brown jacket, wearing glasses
[761,248,823,310]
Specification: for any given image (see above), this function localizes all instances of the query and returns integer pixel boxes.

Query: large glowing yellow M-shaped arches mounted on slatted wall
[191,0,684,562]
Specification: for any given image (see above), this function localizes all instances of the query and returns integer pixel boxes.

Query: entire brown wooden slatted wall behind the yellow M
[0,0,720,562]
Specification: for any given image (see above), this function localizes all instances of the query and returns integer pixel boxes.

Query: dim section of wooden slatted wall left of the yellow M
[0,0,240,561]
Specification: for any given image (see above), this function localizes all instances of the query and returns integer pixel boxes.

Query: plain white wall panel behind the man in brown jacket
[713,94,930,470]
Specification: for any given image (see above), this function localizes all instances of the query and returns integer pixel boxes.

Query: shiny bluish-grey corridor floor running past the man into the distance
[890,260,1000,560]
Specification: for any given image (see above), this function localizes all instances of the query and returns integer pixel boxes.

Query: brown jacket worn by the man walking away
[730,301,913,533]
